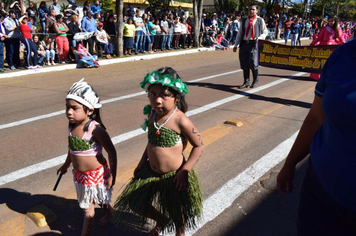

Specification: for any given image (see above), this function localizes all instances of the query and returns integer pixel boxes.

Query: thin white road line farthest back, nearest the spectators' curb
[0,70,242,130]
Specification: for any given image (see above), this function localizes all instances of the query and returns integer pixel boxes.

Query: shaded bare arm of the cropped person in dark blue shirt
[277,95,325,194]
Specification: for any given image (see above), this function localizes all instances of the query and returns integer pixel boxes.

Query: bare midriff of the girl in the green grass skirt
[147,143,183,174]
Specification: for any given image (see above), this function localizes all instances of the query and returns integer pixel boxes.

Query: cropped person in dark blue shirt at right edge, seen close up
[277,37,356,236]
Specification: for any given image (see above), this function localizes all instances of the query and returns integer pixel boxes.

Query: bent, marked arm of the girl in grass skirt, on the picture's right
[173,114,204,191]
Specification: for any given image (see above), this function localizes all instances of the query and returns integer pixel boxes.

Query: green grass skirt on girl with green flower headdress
[113,162,203,232]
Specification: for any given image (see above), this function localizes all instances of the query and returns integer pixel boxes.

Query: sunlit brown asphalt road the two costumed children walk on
[0,41,315,236]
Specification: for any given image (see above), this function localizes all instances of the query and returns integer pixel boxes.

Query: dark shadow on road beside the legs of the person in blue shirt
[221,160,308,236]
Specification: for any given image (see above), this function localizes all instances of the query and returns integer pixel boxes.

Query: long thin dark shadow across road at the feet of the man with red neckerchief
[188,83,312,108]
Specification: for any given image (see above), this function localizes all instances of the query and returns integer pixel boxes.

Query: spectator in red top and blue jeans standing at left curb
[19,15,41,69]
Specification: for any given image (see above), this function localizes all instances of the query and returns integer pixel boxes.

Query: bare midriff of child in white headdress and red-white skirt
[71,154,105,172]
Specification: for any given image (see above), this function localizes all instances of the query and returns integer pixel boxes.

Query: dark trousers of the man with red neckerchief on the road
[239,40,258,81]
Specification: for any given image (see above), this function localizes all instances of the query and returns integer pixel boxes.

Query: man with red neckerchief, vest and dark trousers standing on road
[234,4,268,89]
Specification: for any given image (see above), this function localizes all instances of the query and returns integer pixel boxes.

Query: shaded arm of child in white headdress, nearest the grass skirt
[93,126,117,189]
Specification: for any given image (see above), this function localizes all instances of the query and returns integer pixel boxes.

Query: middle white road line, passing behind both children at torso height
[0,72,305,186]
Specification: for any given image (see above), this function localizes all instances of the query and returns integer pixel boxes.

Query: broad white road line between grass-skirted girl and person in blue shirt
[164,131,299,236]
